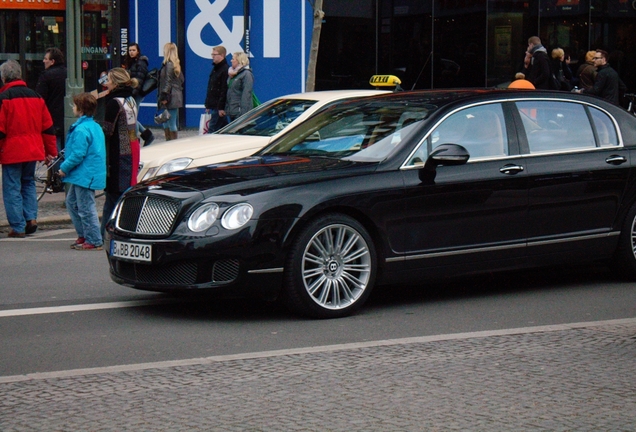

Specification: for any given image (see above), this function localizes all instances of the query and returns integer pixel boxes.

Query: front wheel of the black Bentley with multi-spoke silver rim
[284,214,377,318]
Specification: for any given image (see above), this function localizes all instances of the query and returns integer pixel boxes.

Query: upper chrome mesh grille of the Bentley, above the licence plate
[117,196,179,235]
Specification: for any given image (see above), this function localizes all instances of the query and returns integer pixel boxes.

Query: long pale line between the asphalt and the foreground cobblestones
[0,318,636,384]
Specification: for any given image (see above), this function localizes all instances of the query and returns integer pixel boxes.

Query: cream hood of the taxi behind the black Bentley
[140,134,271,167]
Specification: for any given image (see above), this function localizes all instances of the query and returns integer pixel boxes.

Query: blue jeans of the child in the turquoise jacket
[66,184,103,246]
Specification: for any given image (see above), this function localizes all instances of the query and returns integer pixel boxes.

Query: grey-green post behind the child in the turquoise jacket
[64,0,84,137]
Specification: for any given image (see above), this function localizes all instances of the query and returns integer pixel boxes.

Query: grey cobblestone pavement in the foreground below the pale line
[0,319,636,432]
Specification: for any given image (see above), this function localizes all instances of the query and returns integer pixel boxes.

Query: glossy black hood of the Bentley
[135,156,377,196]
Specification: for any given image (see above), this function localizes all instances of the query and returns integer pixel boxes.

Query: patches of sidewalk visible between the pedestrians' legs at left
[0,127,199,231]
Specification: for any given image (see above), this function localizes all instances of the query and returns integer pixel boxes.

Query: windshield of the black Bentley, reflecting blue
[259,101,437,162]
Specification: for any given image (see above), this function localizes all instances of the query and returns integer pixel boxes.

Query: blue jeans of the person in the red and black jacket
[2,162,38,233]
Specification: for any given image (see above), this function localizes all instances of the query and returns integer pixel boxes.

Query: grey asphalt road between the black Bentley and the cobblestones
[0,228,636,375]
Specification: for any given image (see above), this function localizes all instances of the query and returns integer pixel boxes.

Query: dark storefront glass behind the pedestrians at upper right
[317,0,636,98]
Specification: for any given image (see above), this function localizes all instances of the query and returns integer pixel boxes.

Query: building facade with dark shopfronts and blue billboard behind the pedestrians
[0,0,636,126]
